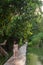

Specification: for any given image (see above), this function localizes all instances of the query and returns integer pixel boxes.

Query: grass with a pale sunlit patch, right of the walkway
[26,47,43,65]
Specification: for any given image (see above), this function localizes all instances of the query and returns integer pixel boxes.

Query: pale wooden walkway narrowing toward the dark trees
[4,44,27,65]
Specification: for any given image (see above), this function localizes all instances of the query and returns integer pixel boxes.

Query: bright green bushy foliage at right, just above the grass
[29,32,43,45]
